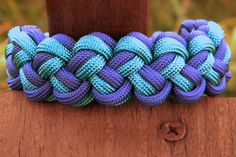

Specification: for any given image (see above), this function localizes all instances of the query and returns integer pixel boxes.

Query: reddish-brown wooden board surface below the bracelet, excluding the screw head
[0,91,236,157]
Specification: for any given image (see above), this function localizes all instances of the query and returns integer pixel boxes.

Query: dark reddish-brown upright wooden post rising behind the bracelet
[46,0,149,40]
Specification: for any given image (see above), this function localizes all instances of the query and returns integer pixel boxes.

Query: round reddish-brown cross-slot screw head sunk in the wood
[160,121,186,142]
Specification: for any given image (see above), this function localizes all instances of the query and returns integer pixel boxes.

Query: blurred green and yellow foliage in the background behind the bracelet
[0,0,236,96]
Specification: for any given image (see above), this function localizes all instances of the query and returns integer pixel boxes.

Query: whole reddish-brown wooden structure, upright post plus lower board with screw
[0,0,236,157]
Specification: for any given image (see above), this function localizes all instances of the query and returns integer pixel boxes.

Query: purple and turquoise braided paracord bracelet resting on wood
[6,20,232,106]
